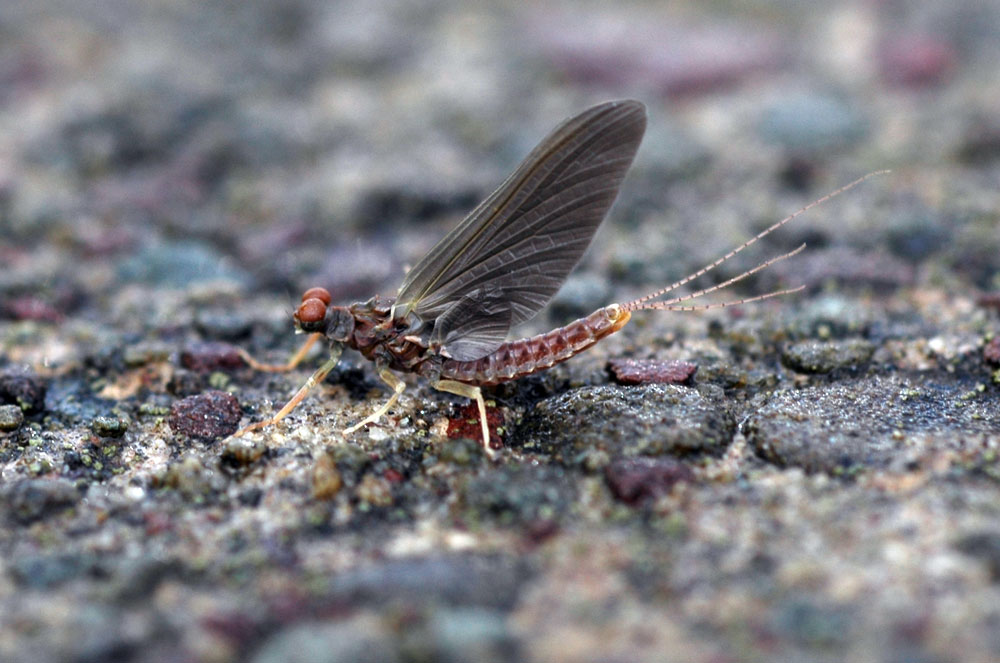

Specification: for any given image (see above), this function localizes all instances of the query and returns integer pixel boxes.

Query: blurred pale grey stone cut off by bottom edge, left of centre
[250,616,404,663]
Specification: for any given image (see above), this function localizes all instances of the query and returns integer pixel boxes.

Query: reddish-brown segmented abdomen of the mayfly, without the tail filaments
[441,304,631,386]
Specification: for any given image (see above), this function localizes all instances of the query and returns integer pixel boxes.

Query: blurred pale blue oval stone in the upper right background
[759,93,868,154]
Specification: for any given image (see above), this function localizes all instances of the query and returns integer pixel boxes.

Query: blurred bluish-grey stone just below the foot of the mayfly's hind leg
[461,465,576,525]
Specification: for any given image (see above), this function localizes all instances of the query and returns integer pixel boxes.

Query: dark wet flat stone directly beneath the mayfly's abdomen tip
[510,385,736,465]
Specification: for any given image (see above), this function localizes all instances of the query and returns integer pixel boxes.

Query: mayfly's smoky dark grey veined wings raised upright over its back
[395,100,646,359]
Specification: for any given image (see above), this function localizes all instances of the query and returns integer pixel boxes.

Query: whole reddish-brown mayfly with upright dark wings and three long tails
[236,100,875,456]
